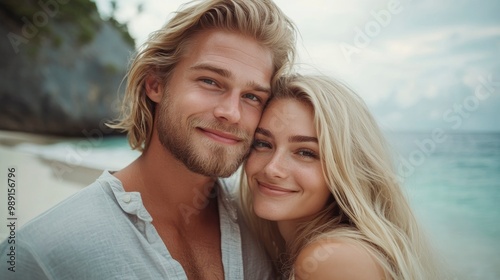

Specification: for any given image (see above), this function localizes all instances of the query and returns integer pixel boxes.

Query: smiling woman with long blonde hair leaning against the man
[241,76,443,280]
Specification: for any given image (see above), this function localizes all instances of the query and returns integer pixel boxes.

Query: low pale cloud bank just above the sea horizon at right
[371,72,500,131]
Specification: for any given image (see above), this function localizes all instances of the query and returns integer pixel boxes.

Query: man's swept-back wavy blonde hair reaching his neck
[109,0,296,151]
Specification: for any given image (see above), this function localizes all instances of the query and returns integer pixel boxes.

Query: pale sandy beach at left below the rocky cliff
[0,131,102,240]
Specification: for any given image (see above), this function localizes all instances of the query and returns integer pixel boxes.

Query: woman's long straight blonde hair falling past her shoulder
[240,75,443,279]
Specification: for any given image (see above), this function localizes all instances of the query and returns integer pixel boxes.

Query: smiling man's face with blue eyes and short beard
[156,31,273,177]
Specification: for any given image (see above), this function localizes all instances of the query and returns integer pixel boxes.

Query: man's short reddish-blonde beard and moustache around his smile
[157,92,252,177]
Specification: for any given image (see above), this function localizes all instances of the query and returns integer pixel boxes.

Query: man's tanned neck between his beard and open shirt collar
[114,138,217,228]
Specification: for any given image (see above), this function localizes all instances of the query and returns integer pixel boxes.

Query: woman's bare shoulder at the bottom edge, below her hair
[294,239,384,280]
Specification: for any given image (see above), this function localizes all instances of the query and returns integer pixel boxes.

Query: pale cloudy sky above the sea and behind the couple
[95,0,500,132]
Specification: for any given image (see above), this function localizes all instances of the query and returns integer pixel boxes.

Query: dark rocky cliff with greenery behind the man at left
[0,0,134,136]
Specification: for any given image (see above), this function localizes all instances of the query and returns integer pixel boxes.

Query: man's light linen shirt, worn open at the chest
[0,171,271,280]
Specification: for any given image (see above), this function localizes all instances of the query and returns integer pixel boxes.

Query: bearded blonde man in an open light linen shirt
[0,0,295,279]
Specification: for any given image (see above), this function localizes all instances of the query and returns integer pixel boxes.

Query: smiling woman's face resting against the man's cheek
[245,99,331,222]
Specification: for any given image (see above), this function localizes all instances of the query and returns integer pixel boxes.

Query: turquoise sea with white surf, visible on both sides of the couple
[16,131,500,280]
